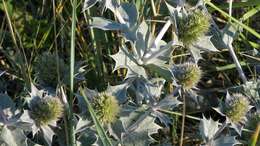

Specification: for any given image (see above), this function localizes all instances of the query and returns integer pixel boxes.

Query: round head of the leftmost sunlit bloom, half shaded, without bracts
[30,96,63,126]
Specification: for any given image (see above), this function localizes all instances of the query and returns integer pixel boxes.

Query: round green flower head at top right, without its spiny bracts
[177,10,210,46]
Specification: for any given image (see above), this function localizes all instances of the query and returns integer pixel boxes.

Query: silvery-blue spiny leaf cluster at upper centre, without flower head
[91,3,175,78]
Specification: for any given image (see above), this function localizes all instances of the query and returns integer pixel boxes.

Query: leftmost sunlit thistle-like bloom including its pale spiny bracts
[29,84,63,145]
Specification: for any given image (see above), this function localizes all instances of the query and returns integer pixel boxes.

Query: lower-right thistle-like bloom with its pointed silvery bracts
[214,93,252,134]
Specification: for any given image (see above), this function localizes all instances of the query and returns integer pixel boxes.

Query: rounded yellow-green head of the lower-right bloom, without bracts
[224,93,250,123]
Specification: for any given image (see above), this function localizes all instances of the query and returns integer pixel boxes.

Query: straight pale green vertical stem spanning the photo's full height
[67,0,77,146]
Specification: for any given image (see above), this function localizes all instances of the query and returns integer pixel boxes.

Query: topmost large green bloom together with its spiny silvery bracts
[166,1,218,62]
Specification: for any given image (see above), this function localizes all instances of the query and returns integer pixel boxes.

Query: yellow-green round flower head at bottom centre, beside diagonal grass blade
[93,93,120,124]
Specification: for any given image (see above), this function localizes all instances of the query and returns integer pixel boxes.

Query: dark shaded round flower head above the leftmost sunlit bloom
[35,52,69,87]
